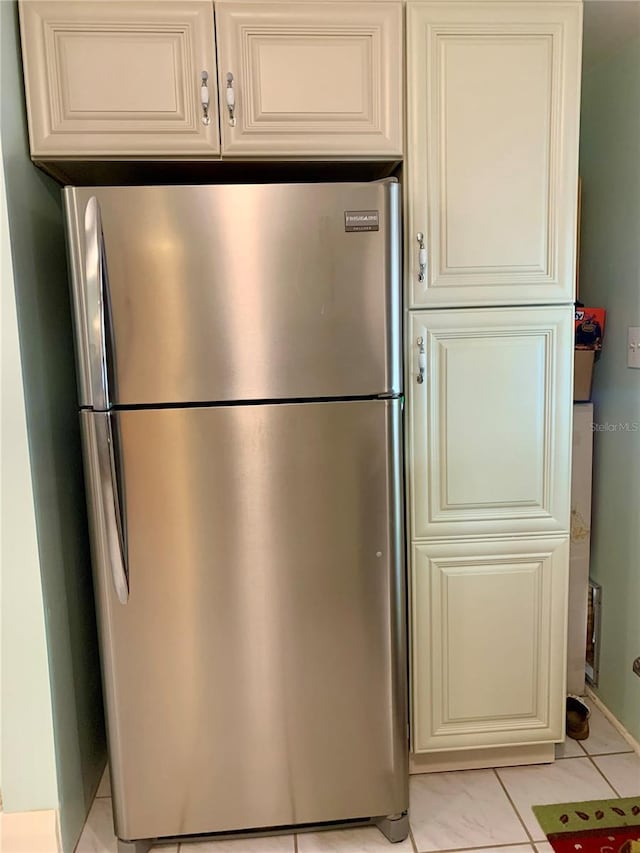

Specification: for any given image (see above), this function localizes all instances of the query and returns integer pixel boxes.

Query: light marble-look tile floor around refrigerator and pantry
[76,707,640,853]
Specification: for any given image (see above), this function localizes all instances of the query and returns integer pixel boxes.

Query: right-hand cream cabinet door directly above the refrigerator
[216,2,403,158]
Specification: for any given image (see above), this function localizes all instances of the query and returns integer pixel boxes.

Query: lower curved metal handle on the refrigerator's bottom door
[95,412,129,604]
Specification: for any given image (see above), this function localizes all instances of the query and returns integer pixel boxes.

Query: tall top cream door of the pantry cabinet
[407,0,582,307]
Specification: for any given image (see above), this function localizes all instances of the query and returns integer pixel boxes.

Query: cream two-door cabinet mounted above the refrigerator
[20,0,404,160]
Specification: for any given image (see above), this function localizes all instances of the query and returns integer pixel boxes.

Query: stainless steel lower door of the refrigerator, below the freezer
[83,400,408,839]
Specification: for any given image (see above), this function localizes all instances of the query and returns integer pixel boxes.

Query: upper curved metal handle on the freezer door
[84,196,109,411]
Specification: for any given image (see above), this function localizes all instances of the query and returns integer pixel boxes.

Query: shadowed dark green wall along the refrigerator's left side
[0,0,105,851]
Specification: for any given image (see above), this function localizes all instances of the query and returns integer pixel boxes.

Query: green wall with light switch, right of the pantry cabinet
[580,0,640,740]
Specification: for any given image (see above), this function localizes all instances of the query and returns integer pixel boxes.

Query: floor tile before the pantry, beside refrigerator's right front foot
[409,759,528,853]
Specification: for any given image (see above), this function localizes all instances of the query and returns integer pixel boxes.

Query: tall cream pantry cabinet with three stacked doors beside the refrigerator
[405,0,582,771]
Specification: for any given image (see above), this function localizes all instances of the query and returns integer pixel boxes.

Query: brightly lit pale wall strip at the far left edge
[0,135,58,811]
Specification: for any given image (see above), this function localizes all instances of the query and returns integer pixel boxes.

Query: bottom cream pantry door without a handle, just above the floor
[411,537,569,753]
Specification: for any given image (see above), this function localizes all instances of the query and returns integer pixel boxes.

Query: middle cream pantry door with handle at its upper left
[407,306,573,539]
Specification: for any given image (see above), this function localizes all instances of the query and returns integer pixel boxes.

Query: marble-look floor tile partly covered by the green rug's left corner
[497,756,616,841]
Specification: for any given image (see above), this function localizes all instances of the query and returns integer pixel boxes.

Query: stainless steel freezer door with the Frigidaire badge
[64,181,401,408]
